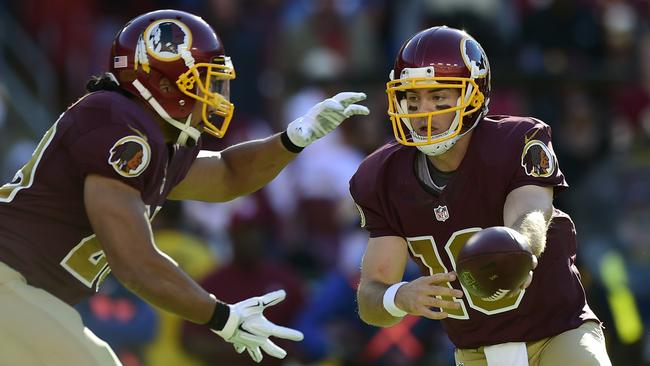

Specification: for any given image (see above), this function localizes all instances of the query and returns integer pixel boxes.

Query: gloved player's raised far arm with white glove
[168,92,369,202]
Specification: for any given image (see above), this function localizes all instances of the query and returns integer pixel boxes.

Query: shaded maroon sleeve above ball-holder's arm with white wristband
[350,160,402,238]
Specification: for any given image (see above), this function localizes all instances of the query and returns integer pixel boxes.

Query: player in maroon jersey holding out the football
[350,26,610,366]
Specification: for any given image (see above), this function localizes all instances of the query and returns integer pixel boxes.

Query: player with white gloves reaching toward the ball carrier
[0,10,368,365]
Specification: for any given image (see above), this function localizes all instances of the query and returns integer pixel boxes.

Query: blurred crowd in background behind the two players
[0,0,650,366]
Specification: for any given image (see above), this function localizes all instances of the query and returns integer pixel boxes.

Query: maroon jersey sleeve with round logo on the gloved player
[67,108,159,192]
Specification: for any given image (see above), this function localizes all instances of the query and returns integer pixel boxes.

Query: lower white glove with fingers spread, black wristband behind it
[213,290,303,362]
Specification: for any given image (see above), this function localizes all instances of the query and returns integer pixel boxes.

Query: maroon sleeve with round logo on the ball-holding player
[508,120,568,192]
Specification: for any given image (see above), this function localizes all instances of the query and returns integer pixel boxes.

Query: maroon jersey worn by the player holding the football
[350,116,597,348]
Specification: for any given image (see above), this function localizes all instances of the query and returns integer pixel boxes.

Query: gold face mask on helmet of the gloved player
[176,56,235,138]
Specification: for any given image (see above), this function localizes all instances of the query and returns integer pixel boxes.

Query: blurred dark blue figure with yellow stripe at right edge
[568,129,650,365]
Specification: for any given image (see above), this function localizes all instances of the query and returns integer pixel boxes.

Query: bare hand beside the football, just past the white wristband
[395,272,463,320]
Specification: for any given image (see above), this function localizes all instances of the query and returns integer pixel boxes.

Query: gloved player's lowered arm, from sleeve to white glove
[84,175,303,362]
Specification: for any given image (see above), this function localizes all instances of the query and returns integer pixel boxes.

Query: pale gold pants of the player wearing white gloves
[0,262,121,366]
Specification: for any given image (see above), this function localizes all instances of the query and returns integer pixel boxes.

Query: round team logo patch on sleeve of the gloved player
[108,136,151,178]
